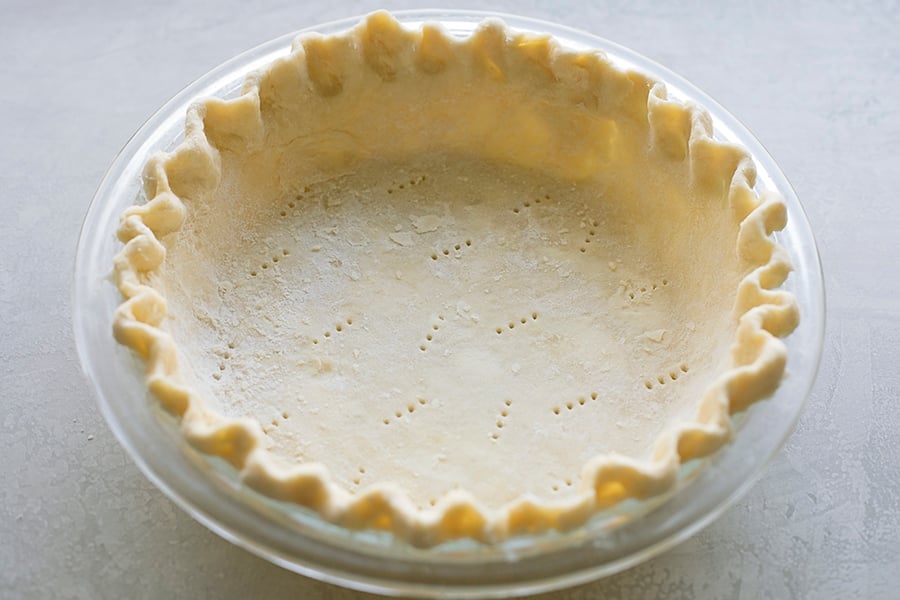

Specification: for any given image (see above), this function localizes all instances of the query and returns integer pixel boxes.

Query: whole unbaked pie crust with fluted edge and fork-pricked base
[114,13,798,546]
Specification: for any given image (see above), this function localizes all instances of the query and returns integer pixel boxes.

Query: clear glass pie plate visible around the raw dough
[74,10,825,597]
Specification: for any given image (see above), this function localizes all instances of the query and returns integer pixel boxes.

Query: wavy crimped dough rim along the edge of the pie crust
[113,12,799,547]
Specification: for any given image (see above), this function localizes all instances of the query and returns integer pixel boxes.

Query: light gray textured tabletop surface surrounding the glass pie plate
[0,0,900,598]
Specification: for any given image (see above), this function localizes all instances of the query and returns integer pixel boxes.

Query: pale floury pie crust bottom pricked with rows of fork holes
[164,154,739,507]
